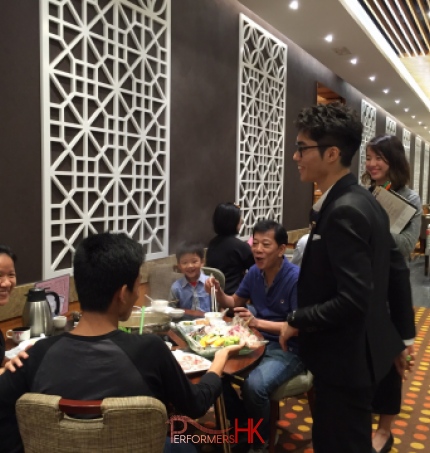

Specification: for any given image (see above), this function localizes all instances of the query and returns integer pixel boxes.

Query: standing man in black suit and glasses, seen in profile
[280,103,415,453]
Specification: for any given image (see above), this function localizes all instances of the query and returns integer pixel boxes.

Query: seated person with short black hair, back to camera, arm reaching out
[0,233,241,453]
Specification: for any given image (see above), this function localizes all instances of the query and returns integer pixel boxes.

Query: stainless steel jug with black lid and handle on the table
[22,288,60,337]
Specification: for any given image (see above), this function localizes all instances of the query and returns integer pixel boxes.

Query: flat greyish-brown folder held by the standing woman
[373,186,417,234]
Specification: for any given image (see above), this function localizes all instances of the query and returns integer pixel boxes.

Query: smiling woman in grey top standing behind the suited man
[363,135,422,453]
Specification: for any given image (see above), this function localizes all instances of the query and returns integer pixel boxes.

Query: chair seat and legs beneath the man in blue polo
[269,371,314,453]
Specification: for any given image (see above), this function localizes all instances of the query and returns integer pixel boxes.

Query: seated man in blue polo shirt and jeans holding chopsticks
[205,220,303,452]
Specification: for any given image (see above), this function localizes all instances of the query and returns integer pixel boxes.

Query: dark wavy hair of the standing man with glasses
[295,102,363,167]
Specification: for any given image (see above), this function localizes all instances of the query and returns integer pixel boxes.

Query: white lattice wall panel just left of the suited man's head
[236,15,287,237]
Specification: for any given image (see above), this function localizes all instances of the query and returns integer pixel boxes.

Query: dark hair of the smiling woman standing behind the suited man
[362,135,411,190]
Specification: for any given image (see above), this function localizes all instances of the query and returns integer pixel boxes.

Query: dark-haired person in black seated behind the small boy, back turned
[206,203,254,295]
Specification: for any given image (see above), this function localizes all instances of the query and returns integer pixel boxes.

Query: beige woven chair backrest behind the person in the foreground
[16,393,167,453]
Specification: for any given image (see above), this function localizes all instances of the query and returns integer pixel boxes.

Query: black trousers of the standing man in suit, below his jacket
[312,377,375,453]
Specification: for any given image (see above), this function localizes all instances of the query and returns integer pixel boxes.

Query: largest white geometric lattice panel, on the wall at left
[41,0,170,278]
